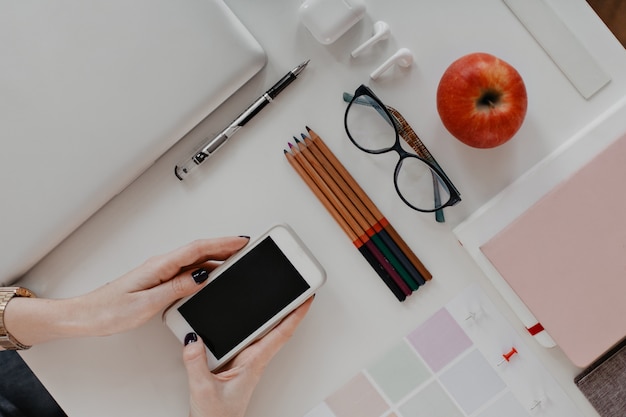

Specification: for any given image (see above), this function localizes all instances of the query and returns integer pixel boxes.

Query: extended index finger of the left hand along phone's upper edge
[140,236,249,289]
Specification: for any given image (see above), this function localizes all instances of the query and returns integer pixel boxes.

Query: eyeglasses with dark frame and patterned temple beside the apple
[344,85,461,222]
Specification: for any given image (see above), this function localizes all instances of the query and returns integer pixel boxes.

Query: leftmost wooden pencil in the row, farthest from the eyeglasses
[284,147,411,301]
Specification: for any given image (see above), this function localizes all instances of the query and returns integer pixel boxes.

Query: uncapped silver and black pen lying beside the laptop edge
[174,60,309,181]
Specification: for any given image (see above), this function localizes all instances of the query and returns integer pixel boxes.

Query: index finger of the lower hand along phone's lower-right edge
[244,297,314,369]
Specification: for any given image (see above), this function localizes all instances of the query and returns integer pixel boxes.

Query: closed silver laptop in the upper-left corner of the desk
[0,0,266,283]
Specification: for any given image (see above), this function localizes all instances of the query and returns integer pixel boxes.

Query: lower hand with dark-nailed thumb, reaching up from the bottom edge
[183,298,313,417]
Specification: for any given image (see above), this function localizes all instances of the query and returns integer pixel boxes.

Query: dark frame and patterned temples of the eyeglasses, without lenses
[344,84,461,216]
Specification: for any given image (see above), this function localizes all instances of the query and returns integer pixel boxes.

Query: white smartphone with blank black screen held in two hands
[163,225,326,370]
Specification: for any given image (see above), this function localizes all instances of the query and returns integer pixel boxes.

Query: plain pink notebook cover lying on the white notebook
[481,135,626,367]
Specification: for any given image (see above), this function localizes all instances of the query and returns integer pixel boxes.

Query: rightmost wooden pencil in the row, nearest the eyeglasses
[306,126,432,281]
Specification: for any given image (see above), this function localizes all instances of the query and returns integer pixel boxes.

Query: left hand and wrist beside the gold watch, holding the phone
[5,237,249,345]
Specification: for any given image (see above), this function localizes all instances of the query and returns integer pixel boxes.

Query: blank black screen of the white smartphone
[178,237,309,359]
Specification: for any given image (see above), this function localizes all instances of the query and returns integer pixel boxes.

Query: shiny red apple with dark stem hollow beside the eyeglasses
[437,52,528,148]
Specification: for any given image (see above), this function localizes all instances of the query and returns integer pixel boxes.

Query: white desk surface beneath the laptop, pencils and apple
[17,0,626,417]
